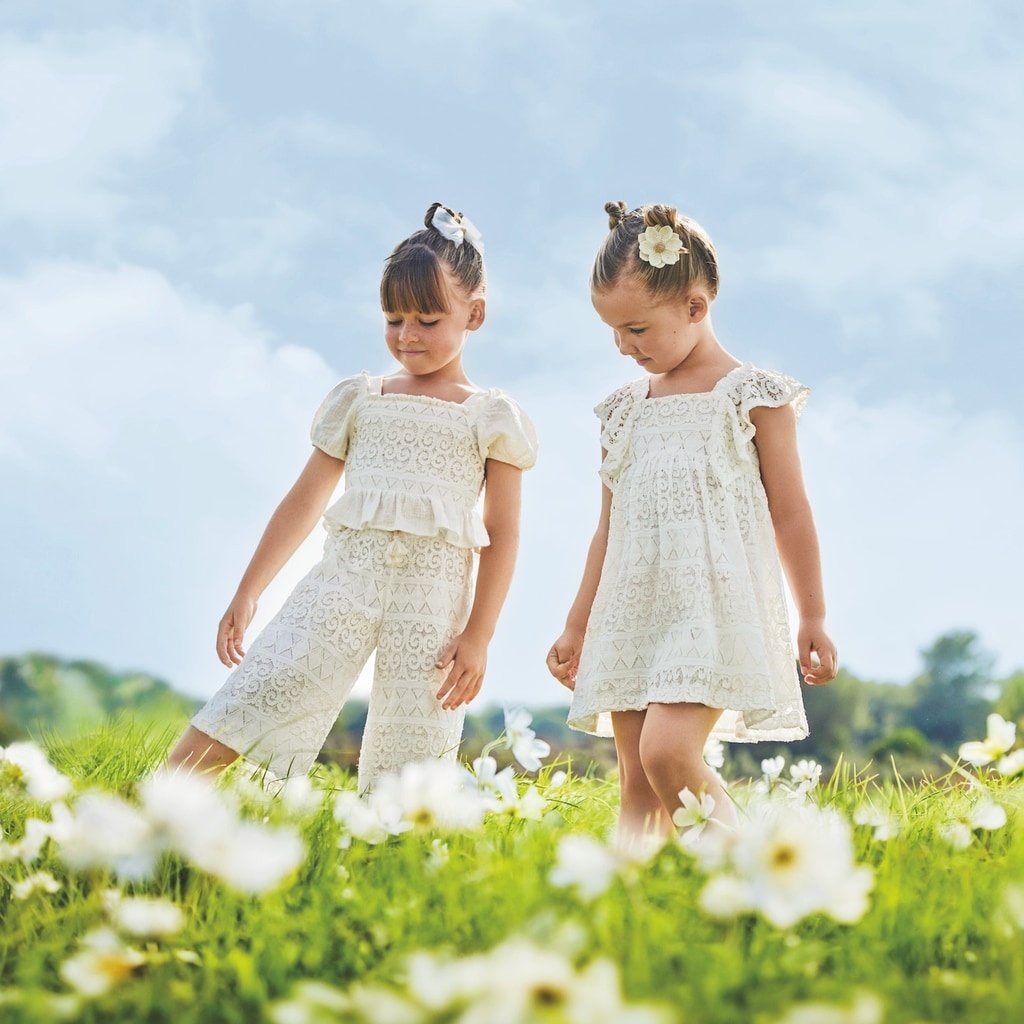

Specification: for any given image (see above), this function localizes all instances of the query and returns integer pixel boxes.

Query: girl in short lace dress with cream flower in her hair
[548,203,837,844]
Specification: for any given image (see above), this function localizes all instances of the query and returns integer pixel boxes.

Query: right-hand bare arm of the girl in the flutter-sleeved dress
[751,406,838,684]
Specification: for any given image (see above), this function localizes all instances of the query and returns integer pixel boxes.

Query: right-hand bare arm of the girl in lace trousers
[436,459,522,709]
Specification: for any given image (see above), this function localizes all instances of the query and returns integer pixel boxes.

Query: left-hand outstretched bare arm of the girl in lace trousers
[217,447,345,668]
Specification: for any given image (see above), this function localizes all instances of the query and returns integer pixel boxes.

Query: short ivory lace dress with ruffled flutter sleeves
[569,364,808,741]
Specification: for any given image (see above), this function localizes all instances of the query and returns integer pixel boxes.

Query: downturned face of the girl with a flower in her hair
[591,275,707,374]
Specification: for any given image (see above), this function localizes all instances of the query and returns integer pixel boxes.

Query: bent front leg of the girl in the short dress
[639,703,736,839]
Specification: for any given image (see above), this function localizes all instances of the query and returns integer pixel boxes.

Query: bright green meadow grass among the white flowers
[0,722,1024,1024]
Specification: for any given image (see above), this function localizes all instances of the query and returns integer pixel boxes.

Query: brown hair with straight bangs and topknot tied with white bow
[381,203,487,313]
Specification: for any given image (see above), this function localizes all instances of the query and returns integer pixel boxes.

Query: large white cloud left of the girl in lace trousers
[0,265,344,692]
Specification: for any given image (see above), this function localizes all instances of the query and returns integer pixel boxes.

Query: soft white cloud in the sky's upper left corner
[0,30,201,227]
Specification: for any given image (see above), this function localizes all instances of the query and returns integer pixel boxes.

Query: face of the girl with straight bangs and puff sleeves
[384,270,484,379]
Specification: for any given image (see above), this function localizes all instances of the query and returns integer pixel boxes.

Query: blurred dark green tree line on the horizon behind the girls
[0,630,1024,778]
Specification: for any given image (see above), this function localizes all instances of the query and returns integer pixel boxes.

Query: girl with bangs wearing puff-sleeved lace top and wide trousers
[169,203,537,791]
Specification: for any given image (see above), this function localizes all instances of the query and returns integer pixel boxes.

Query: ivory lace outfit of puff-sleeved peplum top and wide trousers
[193,374,537,791]
